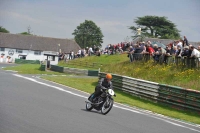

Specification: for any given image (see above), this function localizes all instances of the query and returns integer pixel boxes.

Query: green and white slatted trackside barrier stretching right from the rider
[99,73,200,113]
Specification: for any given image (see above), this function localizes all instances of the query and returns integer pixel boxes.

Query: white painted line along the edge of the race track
[13,74,200,133]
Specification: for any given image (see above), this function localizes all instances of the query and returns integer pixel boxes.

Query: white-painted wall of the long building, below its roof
[0,48,58,65]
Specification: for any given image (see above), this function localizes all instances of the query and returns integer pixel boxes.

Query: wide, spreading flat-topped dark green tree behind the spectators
[129,16,180,39]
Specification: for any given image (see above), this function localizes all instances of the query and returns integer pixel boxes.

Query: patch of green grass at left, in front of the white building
[3,64,65,75]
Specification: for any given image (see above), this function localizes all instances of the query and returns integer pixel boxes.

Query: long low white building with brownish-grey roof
[0,33,80,65]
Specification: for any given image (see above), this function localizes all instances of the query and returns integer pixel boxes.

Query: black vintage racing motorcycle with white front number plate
[85,89,116,115]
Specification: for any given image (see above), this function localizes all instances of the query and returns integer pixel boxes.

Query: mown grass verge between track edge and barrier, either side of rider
[42,76,200,124]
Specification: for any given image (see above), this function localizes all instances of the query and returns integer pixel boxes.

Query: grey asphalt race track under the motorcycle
[0,64,200,133]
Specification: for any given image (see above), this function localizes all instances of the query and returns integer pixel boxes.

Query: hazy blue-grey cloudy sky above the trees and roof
[0,0,200,46]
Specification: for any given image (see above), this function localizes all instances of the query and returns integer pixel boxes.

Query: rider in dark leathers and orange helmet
[88,73,113,102]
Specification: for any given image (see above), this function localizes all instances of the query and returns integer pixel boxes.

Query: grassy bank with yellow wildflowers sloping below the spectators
[59,54,200,91]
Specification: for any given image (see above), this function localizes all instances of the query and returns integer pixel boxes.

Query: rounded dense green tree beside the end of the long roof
[72,20,104,48]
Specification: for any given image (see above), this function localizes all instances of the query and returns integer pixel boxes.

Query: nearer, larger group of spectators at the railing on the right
[128,36,200,63]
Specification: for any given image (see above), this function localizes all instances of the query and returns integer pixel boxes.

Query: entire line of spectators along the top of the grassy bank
[59,36,200,66]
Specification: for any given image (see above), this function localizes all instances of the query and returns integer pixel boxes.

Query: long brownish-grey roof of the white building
[0,32,80,52]
